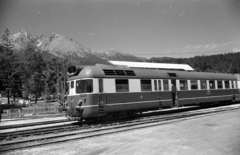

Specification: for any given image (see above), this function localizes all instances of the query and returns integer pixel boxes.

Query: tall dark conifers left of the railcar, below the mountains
[0,29,71,103]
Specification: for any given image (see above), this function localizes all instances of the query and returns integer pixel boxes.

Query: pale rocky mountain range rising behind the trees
[7,30,143,63]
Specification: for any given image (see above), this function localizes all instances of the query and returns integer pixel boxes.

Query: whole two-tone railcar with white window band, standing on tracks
[65,64,240,120]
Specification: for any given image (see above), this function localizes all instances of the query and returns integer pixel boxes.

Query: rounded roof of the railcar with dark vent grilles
[69,66,237,80]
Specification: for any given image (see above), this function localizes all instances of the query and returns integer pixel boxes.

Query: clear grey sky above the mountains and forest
[0,0,240,58]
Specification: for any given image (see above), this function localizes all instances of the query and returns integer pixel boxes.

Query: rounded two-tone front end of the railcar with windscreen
[66,78,99,118]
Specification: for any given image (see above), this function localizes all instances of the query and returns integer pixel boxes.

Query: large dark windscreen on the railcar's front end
[76,80,93,93]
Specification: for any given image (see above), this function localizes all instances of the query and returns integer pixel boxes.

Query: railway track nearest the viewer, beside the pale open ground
[0,104,240,152]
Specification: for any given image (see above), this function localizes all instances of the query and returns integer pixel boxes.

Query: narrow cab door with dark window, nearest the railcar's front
[98,79,107,116]
